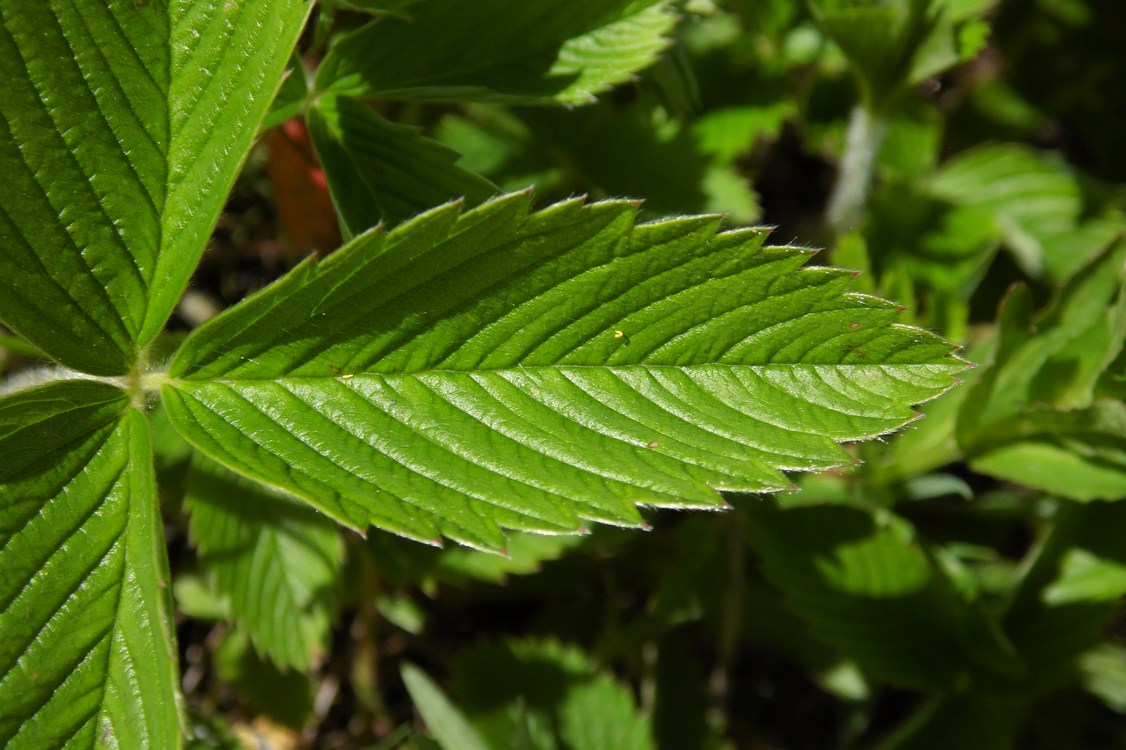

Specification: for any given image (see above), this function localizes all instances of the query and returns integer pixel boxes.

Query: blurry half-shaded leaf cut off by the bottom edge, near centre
[452,641,654,750]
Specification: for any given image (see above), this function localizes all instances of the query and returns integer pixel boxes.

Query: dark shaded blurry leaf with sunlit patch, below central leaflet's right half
[743,502,1021,690]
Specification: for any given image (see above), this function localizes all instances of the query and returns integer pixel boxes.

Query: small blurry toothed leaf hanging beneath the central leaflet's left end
[185,455,343,671]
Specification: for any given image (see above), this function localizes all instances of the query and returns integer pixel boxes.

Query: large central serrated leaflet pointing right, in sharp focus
[162,194,964,548]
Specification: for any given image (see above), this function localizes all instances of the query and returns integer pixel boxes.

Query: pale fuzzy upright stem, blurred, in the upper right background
[826,104,887,235]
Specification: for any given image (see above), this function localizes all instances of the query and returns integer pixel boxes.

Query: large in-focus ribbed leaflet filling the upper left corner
[0,0,310,375]
